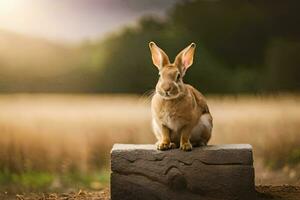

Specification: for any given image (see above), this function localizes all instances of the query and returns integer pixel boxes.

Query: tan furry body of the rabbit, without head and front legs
[151,84,212,147]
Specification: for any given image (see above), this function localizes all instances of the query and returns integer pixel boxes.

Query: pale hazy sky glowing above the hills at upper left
[0,0,178,41]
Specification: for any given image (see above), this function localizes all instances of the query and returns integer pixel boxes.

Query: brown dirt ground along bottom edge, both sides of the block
[0,185,300,200]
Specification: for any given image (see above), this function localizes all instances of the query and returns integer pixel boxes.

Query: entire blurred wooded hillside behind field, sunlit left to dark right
[0,0,300,93]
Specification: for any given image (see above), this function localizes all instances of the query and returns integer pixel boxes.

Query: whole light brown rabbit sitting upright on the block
[149,42,213,151]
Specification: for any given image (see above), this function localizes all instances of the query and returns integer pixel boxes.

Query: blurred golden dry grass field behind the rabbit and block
[0,94,300,190]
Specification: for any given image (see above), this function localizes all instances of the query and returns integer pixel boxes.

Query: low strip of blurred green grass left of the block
[0,170,110,192]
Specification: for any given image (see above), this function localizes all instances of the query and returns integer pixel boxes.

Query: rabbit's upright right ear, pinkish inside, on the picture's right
[175,43,196,74]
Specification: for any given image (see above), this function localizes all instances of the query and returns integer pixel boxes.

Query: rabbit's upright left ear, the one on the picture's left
[149,42,170,70]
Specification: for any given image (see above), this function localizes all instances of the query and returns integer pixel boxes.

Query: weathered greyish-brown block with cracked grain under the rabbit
[111,144,255,200]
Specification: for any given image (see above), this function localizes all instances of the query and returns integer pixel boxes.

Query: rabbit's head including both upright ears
[149,42,196,99]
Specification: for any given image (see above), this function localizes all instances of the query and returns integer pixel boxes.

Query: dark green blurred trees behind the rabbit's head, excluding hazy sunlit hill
[87,0,300,93]
